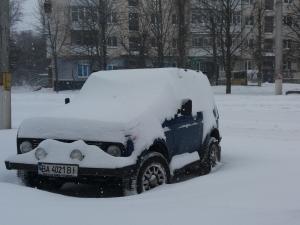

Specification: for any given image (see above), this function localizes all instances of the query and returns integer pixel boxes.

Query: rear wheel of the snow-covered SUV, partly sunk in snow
[200,137,221,175]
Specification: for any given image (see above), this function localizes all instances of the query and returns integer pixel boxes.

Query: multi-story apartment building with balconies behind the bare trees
[47,0,300,88]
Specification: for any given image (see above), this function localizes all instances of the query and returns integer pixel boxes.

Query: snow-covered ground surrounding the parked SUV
[0,84,300,225]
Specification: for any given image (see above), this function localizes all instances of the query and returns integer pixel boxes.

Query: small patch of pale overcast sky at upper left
[16,0,37,31]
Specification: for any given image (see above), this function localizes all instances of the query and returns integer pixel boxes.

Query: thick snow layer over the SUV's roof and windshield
[73,68,213,122]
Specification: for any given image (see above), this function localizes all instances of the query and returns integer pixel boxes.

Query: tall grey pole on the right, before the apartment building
[274,0,283,95]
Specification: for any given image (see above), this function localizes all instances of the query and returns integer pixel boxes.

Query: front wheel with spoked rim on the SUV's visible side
[136,152,170,194]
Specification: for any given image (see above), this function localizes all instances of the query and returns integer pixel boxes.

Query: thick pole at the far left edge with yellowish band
[0,0,11,129]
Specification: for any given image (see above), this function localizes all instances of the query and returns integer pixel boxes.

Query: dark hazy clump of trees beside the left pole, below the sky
[9,0,49,85]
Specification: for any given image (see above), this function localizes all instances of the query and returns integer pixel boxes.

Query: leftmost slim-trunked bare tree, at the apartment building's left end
[38,0,70,91]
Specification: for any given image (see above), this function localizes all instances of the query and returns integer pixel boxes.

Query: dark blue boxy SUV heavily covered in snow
[5,68,221,193]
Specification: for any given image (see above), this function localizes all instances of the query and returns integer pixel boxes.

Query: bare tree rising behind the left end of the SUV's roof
[72,0,122,70]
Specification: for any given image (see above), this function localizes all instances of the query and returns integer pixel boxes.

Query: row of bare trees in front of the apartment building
[46,0,270,93]
